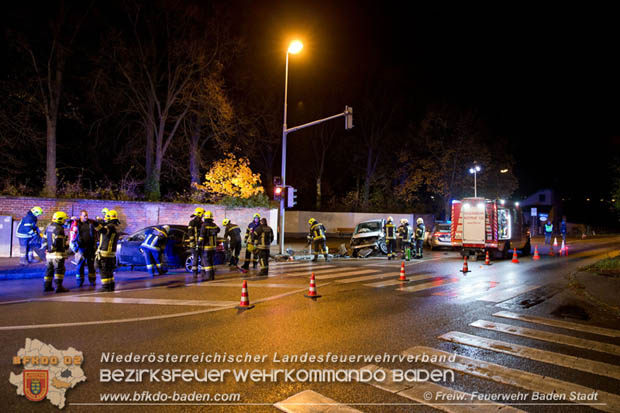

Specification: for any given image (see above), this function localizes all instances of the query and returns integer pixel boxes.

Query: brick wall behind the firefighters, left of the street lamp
[0,196,277,256]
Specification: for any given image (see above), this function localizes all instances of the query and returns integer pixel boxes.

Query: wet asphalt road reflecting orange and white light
[0,238,620,412]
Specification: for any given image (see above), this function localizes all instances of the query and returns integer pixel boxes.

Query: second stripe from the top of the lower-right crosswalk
[470,320,620,356]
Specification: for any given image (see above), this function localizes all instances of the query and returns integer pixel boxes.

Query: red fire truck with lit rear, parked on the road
[451,198,532,258]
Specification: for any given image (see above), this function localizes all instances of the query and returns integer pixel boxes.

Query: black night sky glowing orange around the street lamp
[2,0,620,219]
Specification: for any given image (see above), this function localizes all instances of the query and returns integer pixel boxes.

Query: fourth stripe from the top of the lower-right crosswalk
[403,346,620,413]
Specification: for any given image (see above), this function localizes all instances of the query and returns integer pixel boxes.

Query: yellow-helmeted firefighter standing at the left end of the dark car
[95,209,121,292]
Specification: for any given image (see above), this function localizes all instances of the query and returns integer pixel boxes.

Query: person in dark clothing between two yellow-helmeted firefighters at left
[72,209,97,287]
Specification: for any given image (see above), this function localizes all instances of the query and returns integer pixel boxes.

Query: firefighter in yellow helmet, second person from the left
[43,211,69,293]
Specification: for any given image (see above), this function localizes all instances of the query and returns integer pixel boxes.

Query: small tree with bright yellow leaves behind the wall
[194,153,265,202]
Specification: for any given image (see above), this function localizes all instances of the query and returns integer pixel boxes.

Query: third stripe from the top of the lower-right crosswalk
[439,331,620,380]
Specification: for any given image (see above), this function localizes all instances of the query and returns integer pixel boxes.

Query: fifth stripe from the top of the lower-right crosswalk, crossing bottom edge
[360,364,522,413]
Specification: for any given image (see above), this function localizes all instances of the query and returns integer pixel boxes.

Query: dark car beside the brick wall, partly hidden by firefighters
[116,224,229,272]
